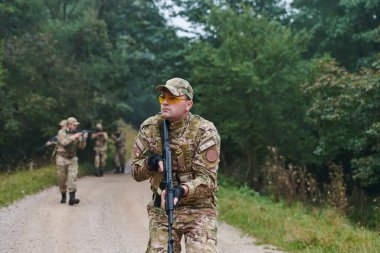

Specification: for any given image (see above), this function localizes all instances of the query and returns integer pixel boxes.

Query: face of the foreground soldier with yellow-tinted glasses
[161,91,193,121]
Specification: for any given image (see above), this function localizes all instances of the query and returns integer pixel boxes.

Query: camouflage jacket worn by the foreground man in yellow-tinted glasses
[132,113,220,208]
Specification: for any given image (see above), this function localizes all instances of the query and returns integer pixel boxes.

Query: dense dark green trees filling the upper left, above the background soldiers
[0,0,185,167]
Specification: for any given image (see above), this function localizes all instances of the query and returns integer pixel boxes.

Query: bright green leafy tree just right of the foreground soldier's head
[187,8,312,184]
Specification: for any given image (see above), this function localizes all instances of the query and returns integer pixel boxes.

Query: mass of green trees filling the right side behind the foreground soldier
[167,0,380,195]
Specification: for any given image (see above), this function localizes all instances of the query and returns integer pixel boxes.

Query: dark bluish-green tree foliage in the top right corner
[290,0,380,70]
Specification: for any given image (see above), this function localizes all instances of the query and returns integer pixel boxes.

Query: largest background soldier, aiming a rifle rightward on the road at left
[56,117,87,205]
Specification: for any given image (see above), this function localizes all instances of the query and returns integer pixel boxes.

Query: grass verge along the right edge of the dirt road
[218,182,380,253]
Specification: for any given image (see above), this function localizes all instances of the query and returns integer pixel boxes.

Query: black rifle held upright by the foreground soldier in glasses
[161,120,174,253]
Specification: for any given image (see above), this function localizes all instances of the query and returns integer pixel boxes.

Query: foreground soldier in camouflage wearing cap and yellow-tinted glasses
[132,78,220,253]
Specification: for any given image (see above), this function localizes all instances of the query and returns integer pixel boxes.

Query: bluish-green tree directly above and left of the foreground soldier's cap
[98,0,188,126]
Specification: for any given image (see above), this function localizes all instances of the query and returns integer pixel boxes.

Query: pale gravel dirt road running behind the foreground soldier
[0,171,277,253]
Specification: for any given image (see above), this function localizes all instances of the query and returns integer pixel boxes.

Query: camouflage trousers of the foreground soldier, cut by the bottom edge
[146,201,217,253]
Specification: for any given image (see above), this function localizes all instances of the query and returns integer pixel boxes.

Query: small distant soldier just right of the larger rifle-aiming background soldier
[91,123,108,177]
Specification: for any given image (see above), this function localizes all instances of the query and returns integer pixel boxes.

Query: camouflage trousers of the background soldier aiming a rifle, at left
[56,155,78,192]
